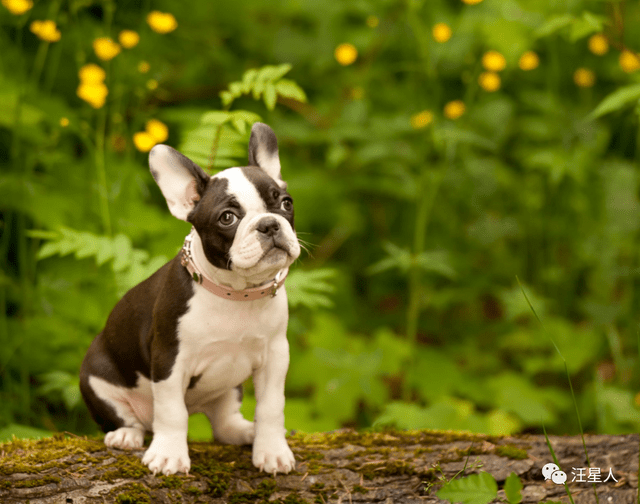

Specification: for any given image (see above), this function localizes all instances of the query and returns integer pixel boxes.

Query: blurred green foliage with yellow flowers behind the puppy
[0,0,640,440]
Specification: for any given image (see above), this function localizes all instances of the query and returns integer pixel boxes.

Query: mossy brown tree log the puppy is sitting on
[0,430,640,504]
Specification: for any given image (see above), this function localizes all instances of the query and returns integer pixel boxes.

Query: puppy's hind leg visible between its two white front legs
[203,385,255,445]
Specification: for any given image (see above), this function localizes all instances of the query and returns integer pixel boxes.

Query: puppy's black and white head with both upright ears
[149,123,300,281]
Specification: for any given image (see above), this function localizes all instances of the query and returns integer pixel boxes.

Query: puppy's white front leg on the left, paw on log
[142,365,191,475]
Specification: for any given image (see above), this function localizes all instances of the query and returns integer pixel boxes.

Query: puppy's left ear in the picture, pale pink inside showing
[149,144,210,221]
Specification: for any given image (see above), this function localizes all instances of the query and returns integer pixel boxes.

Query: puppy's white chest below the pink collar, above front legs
[176,285,287,403]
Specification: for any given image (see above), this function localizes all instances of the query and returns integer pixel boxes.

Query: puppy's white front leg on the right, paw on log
[253,329,296,474]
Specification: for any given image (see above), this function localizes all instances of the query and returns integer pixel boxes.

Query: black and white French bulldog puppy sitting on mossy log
[80,123,300,474]
